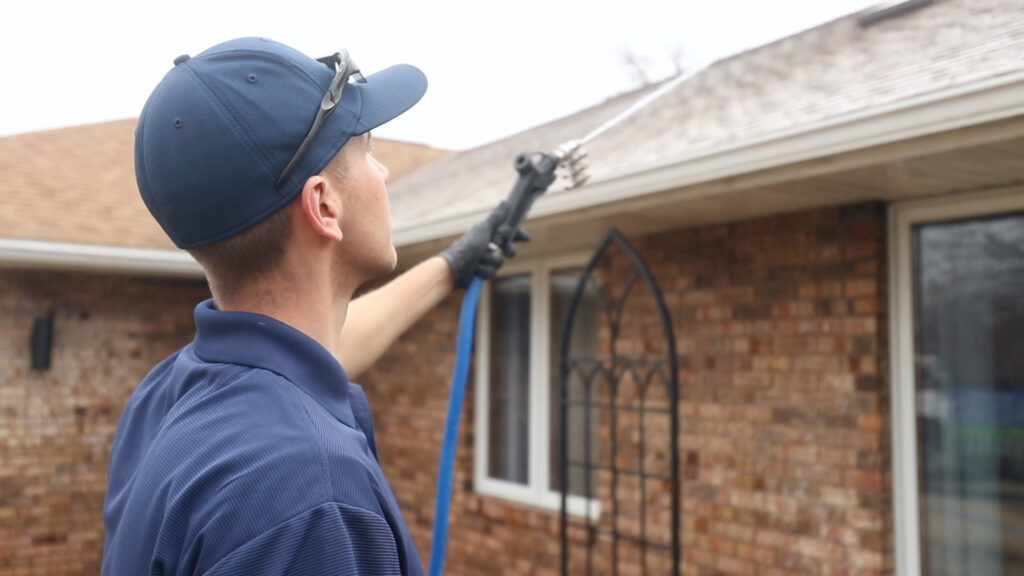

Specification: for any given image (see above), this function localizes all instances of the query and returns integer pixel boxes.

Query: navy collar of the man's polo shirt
[193,299,355,428]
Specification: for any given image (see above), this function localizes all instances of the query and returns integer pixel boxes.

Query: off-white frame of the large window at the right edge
[889,187,1024,576]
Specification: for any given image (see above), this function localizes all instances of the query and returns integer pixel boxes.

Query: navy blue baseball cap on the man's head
[135,38,427,248]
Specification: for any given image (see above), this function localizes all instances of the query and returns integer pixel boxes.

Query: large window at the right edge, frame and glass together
[891,190,1024,576]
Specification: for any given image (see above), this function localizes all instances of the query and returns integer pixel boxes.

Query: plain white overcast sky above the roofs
[0,0,880,149]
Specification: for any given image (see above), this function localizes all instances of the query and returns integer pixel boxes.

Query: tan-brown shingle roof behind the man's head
[0,119,449,249]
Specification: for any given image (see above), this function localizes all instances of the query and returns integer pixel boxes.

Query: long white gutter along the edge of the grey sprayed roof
[394,72,1024,247]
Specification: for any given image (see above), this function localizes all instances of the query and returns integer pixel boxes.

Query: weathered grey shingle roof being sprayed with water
[391,0,1024,231]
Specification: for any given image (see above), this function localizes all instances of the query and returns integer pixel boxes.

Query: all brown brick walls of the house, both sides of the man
[0,199,892,576]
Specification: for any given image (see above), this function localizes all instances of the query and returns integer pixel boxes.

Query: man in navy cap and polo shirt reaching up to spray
[102,38,520,576]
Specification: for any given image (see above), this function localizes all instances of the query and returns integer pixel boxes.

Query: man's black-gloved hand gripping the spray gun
[440,202,529,289]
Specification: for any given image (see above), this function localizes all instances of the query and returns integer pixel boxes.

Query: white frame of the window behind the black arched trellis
[473,253,601,520]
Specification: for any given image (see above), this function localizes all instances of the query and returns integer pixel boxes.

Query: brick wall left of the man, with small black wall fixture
[0,270,208,576]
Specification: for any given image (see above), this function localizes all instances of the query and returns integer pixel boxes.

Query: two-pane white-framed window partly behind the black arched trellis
[474,253,600,515]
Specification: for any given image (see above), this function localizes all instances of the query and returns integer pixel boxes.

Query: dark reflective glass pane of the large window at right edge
[913,214,1024,576]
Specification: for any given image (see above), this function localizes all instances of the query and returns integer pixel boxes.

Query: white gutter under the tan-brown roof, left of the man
[0,238,203,278]
